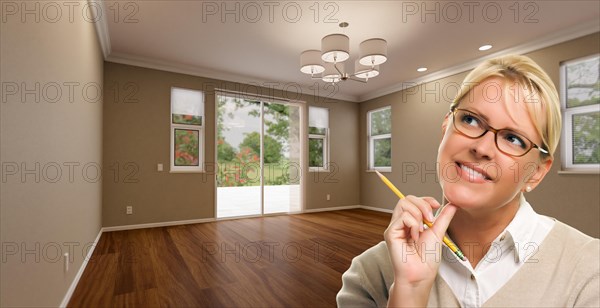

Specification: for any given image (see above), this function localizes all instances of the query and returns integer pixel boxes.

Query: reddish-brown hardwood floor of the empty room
[68,209,391,307]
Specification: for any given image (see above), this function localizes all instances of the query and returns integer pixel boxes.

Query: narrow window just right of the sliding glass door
[308,107,329,171]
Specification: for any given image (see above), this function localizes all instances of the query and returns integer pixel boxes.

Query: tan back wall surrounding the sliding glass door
[103,62,359,226]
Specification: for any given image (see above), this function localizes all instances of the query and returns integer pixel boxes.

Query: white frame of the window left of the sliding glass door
[169,87,206,173]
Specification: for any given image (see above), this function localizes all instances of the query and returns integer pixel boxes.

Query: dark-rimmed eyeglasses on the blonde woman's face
[450,107,548,157]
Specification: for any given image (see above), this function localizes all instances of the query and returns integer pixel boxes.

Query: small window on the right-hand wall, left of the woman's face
[367,106,392,171]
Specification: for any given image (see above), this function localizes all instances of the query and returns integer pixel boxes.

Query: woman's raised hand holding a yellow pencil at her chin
[384,196,456,306]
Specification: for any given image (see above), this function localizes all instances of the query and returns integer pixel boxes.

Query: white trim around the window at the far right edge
[559,54,600,174]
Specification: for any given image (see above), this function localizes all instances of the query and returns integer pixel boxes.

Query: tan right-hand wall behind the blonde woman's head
[360,33,600,237]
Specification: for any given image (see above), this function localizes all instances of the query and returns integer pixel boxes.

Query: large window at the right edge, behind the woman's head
[561,55,600,173]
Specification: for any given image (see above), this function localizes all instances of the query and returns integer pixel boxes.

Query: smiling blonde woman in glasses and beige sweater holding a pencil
[337,55,600,307]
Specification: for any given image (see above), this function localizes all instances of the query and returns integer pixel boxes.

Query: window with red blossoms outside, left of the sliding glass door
[171,88,204,172]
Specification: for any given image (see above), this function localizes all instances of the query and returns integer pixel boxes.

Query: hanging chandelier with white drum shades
[300,22,387,83]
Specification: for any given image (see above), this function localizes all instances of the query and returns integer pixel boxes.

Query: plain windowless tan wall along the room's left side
[0,2,103,307]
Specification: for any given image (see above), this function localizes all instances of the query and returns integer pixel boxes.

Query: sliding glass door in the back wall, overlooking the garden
[217,94,302,218]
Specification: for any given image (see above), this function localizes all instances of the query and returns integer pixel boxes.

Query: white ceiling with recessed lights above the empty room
[100,0,600,101]
